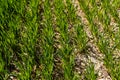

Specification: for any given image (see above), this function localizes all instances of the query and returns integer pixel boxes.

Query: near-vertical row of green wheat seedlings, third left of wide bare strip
[40,0,54,80]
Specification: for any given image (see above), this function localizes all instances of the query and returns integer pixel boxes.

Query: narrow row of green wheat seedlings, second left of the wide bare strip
[55,0,73,79]
